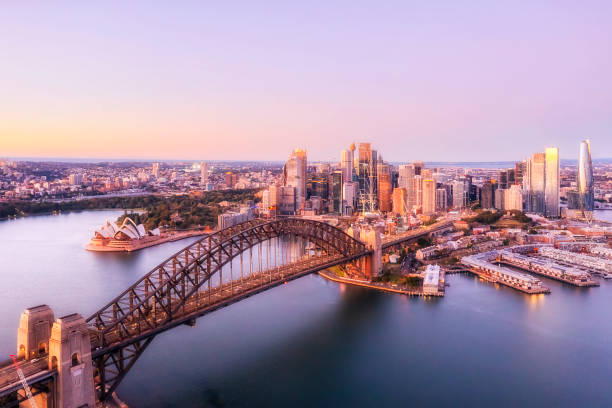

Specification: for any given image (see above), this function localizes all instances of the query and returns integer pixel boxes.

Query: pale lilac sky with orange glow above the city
[0,2,612,162]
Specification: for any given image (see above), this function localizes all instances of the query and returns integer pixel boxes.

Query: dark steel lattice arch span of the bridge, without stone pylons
[87,218,370,400]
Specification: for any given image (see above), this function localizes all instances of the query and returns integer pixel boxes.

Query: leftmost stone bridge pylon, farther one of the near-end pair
[17,305,54,360]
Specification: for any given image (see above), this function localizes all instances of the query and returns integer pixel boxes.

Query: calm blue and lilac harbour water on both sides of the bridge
[0,211,612,408]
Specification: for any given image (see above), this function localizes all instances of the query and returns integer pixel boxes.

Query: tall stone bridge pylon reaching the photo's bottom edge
[49,313,95,408]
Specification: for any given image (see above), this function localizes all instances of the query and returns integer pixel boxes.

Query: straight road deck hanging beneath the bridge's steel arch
[90,255,352,358]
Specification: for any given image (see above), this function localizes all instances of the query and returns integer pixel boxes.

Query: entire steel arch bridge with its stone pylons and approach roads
[0,217,448,407]
